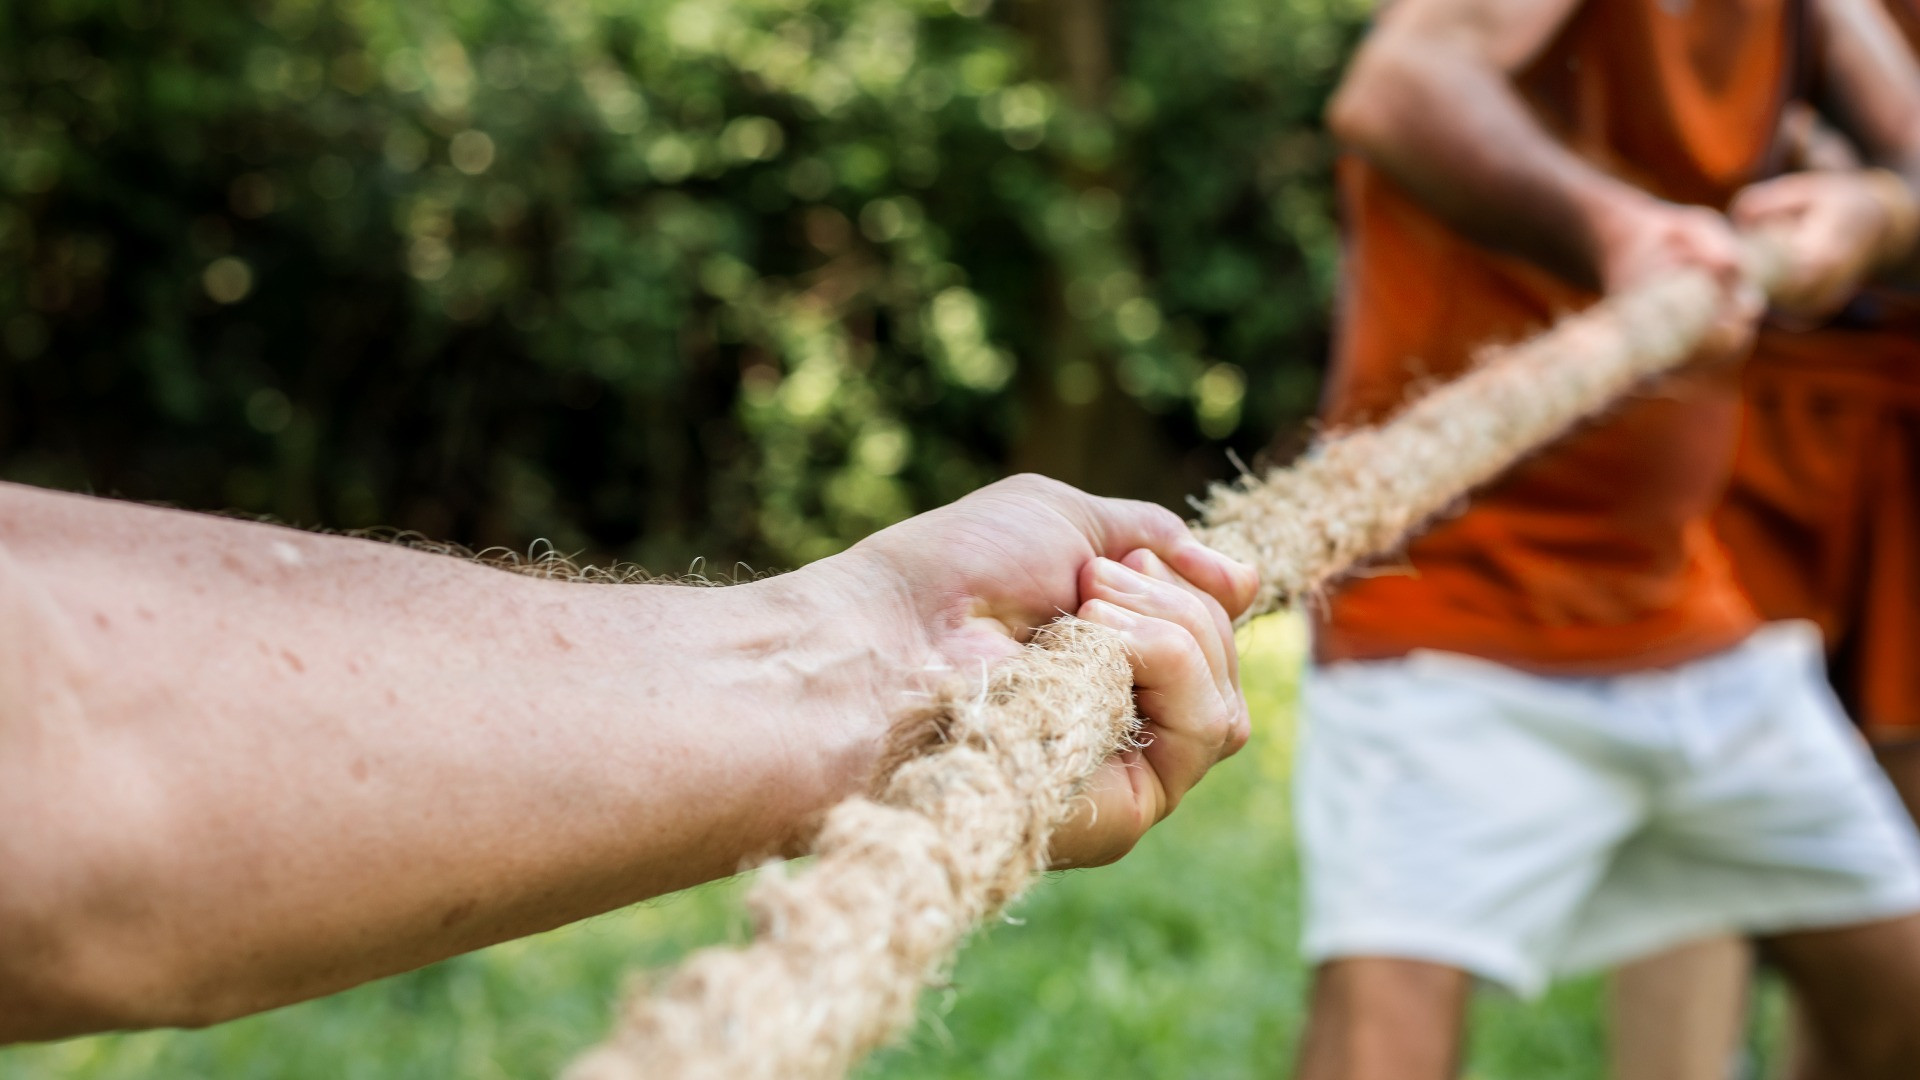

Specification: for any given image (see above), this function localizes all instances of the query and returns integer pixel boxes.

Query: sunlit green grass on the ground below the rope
[0,619,1776,1080]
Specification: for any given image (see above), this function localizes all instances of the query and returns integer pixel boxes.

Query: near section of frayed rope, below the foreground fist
[568,619,1137,1080]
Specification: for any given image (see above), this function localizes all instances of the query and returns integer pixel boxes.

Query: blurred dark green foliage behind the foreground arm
[0,0,1363,569]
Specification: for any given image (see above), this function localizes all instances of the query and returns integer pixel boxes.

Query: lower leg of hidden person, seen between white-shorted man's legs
[1609,934,1753,1080]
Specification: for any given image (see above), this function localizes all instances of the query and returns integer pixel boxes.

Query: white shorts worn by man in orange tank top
[1296,623,1920,995]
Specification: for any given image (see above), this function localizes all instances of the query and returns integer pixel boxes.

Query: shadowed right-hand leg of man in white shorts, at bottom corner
[1768,915,1920,1080]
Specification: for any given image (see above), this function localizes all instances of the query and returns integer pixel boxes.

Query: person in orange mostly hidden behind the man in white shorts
[1611,14,1920,1078]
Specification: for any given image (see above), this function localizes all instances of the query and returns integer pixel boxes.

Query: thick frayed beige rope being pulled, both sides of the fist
[566,242,1784,1080]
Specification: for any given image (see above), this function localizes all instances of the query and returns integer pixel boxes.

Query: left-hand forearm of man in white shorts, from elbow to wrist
[1331,27,1651,286]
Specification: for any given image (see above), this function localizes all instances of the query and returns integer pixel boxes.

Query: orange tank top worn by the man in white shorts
[1315,0,1799,673]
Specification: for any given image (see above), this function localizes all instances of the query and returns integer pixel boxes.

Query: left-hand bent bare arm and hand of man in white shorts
[1329,0,1763,359]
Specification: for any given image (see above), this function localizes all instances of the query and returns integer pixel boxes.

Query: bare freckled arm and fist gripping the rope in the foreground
[0,479,1252,1042]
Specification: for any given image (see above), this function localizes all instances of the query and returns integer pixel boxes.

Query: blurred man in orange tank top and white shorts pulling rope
[1296,0,1920,1080]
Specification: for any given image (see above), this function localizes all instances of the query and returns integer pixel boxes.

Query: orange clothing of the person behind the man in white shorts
[1715,0,1920,740]
